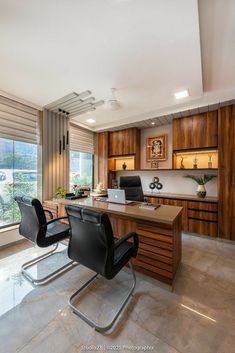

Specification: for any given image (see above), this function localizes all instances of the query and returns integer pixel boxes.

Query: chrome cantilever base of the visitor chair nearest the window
[21,243,78,286]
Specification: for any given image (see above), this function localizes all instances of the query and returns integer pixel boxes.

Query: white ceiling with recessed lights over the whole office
[0,0,235,130]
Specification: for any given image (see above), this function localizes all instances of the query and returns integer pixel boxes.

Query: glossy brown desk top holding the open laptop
[52,197,183,225]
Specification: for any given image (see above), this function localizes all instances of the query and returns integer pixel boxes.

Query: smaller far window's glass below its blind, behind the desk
[70,151,93,191]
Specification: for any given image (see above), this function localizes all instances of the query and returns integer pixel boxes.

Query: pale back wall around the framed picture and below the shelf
[117,124,217,196]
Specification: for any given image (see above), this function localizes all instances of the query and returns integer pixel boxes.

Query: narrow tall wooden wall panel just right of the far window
[97,131,109,189]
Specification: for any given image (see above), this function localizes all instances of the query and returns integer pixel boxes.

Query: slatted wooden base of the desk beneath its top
[51,200,181,284]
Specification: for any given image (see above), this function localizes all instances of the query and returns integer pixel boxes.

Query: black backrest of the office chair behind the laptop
[120,175,144,202]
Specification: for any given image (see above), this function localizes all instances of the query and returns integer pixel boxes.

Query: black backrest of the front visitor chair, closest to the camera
[66,205,114,277]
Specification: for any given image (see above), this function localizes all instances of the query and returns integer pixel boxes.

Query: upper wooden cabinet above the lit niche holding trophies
[173,110,218,150]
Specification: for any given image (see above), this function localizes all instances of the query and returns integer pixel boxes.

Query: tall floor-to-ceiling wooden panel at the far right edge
[219,105,235,241]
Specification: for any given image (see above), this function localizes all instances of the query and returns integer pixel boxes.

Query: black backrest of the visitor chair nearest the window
[15,195,47,246]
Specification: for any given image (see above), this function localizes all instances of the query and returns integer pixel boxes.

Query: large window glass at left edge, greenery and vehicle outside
[0,138,37,227]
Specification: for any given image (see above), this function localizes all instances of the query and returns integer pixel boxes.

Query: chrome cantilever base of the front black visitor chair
[69,260,136,332]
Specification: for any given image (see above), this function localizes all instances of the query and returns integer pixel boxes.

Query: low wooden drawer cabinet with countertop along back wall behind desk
[147,197,218,237]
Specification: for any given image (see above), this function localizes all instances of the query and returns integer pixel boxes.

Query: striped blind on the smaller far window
[69,123,94,153]
